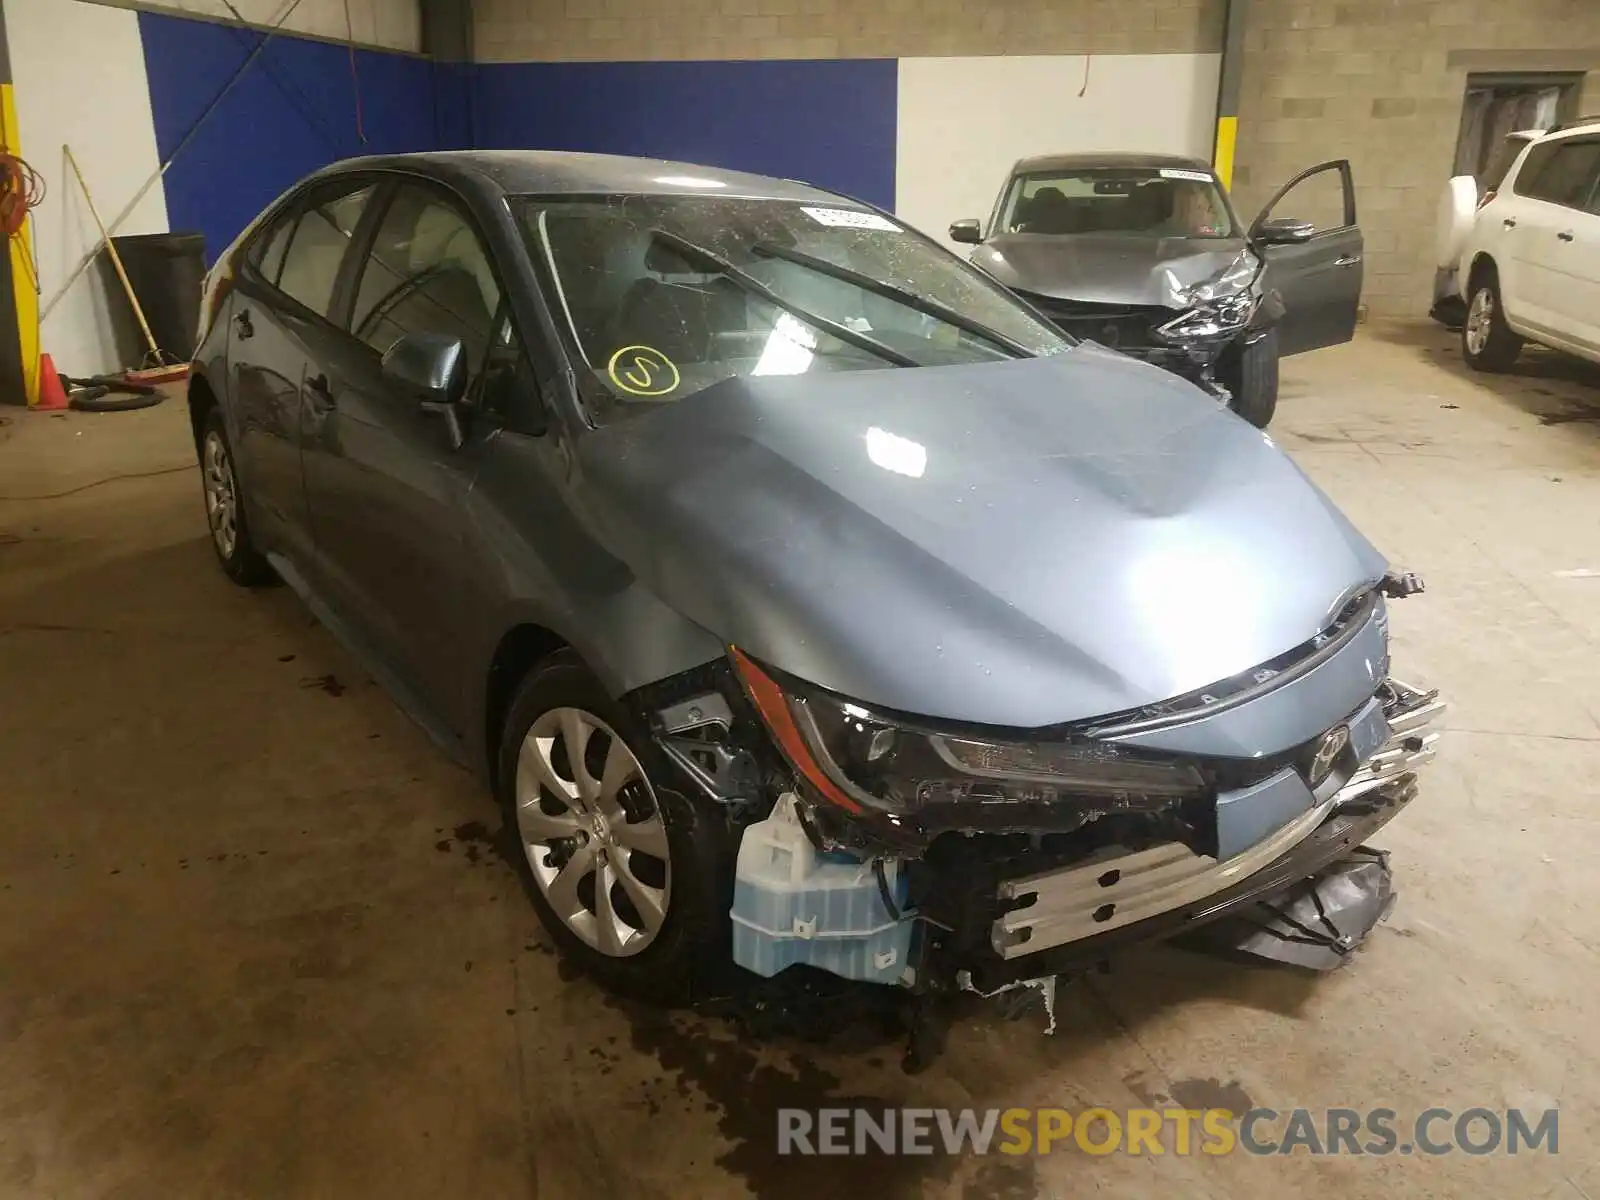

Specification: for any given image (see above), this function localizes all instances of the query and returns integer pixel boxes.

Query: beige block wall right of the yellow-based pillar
[1234,0,1600,315]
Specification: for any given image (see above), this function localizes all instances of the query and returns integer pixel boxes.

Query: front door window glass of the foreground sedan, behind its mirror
[350,186,501,368]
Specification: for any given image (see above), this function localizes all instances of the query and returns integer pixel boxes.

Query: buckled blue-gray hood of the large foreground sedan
[578,346,1386,728]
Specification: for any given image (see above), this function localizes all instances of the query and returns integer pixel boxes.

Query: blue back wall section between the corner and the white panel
[472,59,898,208]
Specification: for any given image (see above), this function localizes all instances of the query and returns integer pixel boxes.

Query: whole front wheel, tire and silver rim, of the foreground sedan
[496,651,733,1005]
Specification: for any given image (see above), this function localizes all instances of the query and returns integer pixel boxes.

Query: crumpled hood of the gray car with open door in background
[973,234,1245,309]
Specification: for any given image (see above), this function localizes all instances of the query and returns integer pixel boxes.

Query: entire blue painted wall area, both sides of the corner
[139,13,898,261]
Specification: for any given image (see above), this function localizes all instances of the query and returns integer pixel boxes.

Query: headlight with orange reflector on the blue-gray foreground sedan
[733,651,1205,813]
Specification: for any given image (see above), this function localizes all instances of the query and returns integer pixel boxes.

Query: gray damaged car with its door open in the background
[950,154,1362,429]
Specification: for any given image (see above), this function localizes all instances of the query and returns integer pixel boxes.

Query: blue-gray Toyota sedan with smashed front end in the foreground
[189,152,1442,1036]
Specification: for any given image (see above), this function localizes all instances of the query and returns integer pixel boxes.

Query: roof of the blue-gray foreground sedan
[308,150,843,205]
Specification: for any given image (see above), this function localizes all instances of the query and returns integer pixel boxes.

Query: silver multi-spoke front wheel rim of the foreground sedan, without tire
[517,707,672,958]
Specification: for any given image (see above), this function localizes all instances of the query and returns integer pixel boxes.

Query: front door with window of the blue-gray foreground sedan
[306,181,501,720]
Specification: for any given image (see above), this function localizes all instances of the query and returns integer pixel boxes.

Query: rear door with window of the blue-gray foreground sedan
[227,179,371,570]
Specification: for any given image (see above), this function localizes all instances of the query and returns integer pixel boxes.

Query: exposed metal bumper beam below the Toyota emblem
[933,685,1445,990]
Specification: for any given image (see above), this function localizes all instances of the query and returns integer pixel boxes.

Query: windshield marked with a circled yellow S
[520,195,1072,421]
